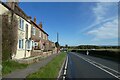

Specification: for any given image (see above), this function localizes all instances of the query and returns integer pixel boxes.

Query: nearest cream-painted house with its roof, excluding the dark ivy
[0,2,32,59]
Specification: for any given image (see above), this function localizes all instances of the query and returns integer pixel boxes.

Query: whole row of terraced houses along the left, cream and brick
[0,2,57,59]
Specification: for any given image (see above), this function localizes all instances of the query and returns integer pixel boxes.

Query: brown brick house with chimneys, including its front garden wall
[31,17,49,55]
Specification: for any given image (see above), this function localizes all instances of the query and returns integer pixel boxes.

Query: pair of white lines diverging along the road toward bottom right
[72,53,120,79]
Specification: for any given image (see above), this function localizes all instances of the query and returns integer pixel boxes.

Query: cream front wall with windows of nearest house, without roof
[13,15,32,59]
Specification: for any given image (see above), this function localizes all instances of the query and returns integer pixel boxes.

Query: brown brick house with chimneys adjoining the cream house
[31,17,49,50]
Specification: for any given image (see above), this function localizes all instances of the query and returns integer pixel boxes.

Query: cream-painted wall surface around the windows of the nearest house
[14,15,31,59]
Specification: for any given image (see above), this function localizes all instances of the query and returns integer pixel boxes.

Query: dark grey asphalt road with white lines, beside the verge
[66,52,120,80]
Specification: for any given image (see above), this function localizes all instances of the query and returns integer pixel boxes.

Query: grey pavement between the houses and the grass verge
[3,53,59,79]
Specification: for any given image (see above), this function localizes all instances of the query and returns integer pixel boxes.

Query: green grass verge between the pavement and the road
[27,52,66,79]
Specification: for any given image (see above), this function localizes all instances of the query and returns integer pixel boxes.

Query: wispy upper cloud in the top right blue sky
[80,2,118,33]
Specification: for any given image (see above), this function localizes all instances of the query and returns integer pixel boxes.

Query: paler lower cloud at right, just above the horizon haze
[87,18,118,40]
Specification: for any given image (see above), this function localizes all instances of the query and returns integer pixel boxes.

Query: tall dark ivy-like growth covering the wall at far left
[2,12,18,60]
